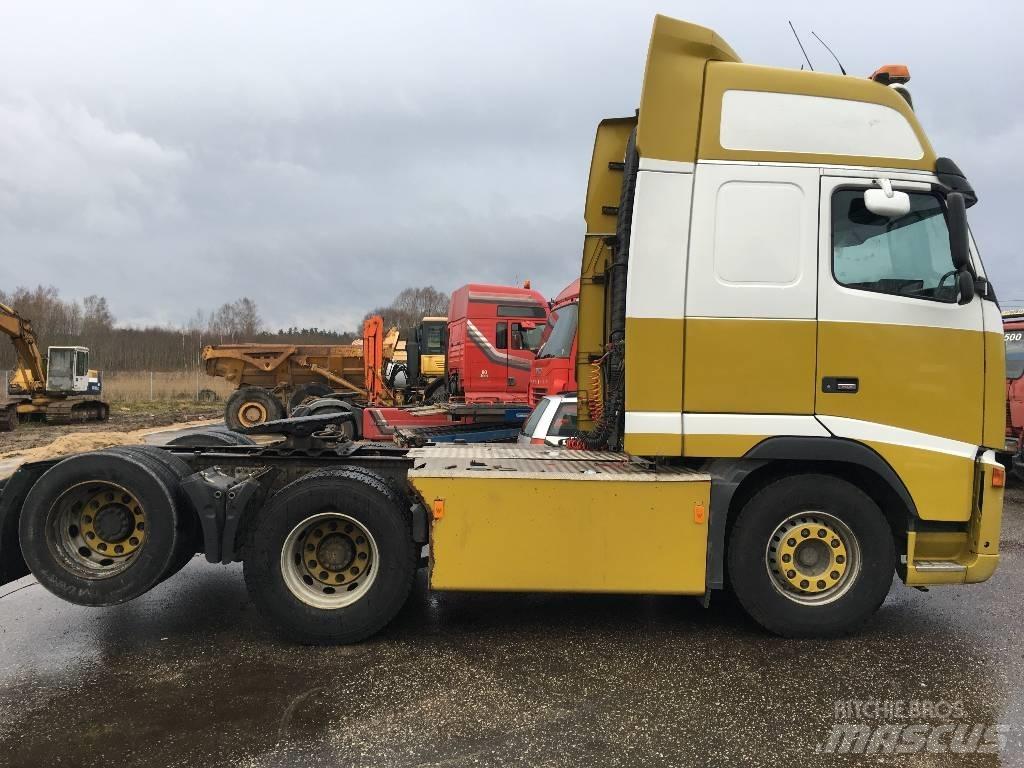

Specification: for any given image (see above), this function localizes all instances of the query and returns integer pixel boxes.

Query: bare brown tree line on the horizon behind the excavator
[0,286,447,371]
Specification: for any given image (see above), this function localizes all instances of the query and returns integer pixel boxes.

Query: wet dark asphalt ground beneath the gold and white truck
[0,489,1024,768]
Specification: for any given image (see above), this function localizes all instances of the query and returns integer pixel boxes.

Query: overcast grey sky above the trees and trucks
[0,0,1024,329]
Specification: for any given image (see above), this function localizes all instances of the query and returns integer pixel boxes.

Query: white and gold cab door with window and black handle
[815,176,985,520]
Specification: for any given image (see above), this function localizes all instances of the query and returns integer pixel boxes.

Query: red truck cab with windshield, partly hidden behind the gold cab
[529,279,580,408]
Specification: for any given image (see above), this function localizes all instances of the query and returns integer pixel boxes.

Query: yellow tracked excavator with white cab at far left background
[0,304,111,432]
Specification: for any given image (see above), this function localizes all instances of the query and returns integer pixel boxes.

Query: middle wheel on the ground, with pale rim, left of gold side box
[244,470,418,644]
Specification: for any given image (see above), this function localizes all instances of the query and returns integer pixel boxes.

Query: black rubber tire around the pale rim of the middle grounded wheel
[243,469,419,645]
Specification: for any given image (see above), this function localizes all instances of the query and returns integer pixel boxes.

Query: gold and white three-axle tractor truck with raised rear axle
[0,16,1006,643]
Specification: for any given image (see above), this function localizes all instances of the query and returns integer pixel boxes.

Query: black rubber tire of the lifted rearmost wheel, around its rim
[18,451,182,605]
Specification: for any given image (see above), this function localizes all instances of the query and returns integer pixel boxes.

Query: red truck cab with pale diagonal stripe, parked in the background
[445,283,548,402]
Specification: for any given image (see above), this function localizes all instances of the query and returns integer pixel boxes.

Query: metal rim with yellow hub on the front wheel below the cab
[766,513,856,601]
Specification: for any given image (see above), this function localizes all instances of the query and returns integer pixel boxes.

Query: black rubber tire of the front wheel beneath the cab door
[727,474,896,637]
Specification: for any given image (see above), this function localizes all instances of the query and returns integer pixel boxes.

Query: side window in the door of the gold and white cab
[831,188,956,302]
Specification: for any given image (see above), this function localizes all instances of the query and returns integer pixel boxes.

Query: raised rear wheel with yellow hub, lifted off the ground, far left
[18,451,182,605]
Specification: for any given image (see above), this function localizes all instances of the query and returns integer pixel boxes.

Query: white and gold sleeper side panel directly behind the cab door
[684,164,824,456]
